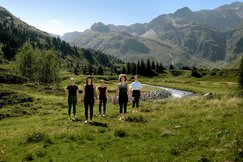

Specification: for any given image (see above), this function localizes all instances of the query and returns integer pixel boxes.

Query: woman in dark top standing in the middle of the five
[98,80,108,116]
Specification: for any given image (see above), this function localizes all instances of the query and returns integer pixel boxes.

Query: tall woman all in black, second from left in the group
[83,76,96,123]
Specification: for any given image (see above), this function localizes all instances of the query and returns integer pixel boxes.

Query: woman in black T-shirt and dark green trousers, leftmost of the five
[64,78,79,120]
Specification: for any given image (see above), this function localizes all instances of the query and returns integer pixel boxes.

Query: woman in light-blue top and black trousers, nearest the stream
[131,75,142,112]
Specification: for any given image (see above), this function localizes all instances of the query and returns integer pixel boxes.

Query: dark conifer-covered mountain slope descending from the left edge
[0,6,121,69]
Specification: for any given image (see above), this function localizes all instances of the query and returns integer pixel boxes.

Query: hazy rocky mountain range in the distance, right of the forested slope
[61,2,243,67]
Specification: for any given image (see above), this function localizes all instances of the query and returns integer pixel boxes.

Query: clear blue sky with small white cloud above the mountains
[0,0,243,35]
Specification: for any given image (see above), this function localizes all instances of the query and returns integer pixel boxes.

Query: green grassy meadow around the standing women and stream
[0,66,243,162]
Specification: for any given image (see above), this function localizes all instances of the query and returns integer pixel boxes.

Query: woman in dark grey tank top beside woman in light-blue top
[115,74,129,120]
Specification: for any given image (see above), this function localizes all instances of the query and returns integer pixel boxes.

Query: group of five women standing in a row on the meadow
[64,74,142,123]
